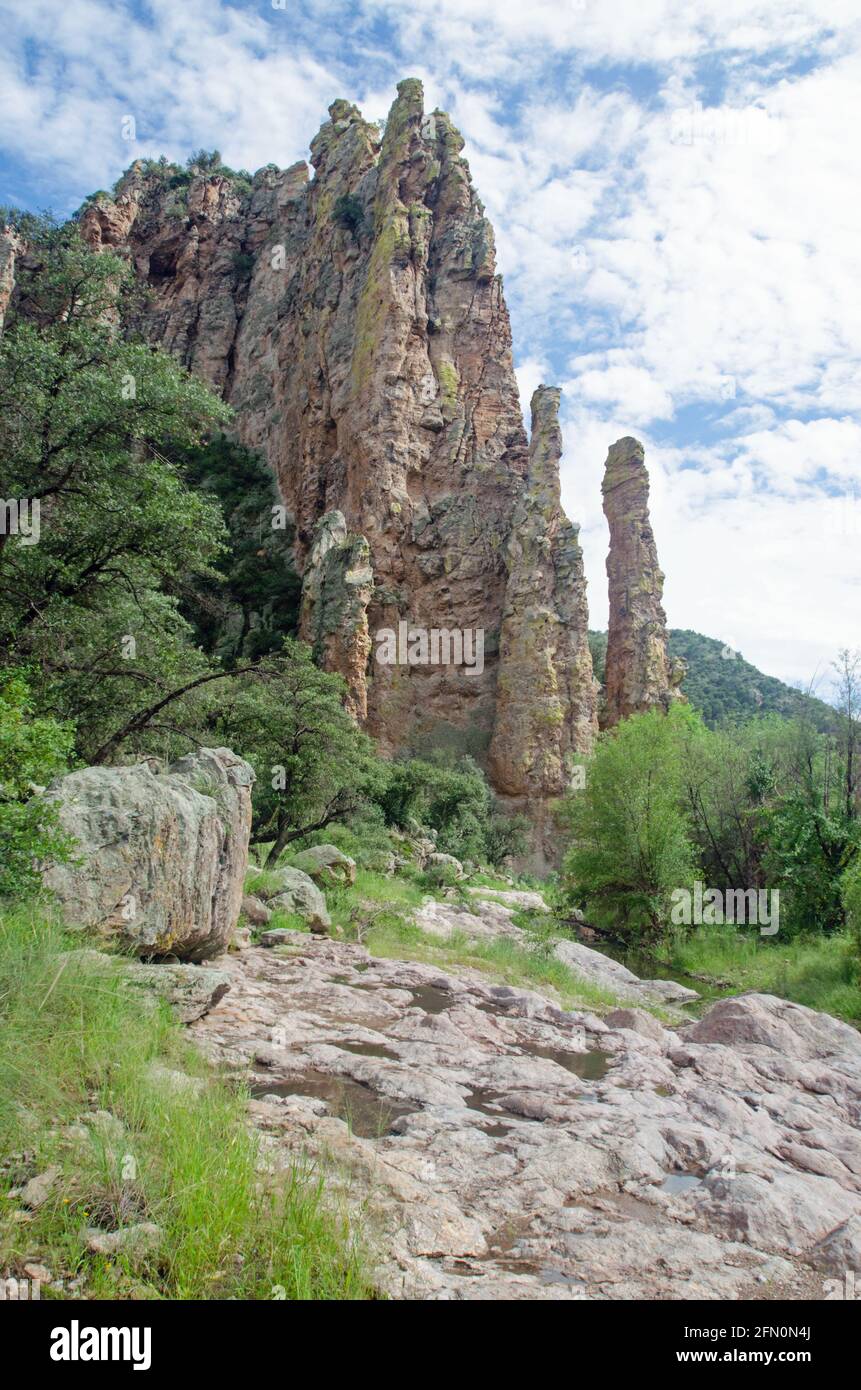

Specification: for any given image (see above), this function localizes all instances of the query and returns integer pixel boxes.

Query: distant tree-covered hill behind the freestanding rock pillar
[588,628,837,730]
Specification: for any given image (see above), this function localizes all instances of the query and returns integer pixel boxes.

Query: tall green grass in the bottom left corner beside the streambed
[0,910,374,1300]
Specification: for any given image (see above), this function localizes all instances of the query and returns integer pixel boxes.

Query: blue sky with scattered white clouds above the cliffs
[0,0,861,698]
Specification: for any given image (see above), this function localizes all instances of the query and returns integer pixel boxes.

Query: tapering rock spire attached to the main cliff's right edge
[490,386,598,801]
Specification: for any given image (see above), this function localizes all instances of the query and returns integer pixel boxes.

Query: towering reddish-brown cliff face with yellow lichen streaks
[81,81,595,796]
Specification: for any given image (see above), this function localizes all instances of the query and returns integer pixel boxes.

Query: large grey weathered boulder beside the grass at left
[45,748,255,960]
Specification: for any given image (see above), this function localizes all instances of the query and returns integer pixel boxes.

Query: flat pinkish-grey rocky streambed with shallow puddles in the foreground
[191,909,861,1300]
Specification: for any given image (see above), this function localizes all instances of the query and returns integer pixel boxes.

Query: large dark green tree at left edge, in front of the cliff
[0,221,228,758]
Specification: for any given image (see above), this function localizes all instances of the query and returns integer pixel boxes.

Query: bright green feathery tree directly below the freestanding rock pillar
[565,706,697,941]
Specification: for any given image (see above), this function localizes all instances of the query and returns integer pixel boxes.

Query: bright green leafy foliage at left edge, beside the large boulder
[0,671,72,898]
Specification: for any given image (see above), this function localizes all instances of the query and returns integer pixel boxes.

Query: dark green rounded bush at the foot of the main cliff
[377,753,526,863]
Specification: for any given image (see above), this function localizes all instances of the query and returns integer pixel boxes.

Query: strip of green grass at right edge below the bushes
[668,927,861,1023]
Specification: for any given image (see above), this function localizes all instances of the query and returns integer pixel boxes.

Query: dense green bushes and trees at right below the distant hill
[563,675,861,967]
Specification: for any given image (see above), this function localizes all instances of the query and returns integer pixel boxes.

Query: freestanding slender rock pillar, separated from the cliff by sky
[601,436,684,728]
